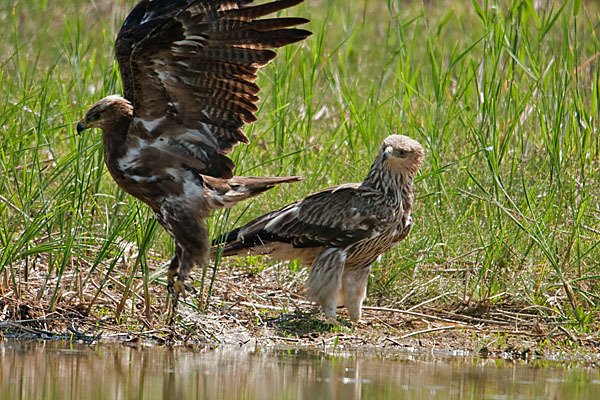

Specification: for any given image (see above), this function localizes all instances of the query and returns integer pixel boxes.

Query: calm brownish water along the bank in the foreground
[0,341,600,399]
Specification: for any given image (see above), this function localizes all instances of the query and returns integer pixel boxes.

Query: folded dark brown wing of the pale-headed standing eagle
[228,183,393,247]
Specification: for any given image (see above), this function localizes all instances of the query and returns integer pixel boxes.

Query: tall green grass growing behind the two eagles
[0,0,600,331]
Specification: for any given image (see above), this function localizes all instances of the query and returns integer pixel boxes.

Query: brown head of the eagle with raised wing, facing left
[77,95,133,133]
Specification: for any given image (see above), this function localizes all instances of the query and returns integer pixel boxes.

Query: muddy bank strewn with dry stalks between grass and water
[0,260,600,359]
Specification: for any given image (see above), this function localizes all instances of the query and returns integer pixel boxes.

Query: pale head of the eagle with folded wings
[379,135,425,175]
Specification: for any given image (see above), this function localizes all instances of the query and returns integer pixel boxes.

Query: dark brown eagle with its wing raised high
[77,0,310,305]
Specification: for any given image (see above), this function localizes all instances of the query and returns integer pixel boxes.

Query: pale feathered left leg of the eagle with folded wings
[304,249,346,325]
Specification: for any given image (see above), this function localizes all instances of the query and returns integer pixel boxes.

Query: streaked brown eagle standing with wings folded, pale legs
[213,135,424,324]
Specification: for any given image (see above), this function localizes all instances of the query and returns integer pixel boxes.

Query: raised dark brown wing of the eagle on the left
[115,0,310,173]
